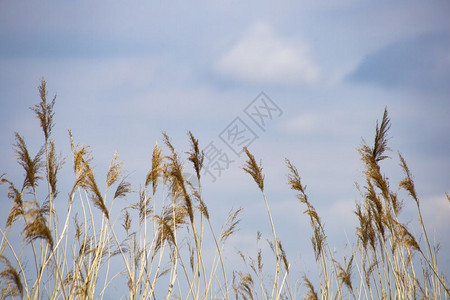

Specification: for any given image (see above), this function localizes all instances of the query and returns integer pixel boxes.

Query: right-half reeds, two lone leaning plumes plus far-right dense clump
[235,110,450,299]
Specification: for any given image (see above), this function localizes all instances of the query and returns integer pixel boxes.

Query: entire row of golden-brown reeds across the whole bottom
[0,80,450,299]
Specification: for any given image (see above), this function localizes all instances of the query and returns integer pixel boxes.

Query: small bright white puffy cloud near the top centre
[216,23,319,85]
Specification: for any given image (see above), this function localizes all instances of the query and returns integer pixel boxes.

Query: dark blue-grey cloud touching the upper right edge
[348,34,450,91]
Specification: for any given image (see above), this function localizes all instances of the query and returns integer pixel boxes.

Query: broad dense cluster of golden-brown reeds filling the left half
[0,80,241,299]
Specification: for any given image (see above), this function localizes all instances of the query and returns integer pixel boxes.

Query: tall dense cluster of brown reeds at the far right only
[355,110,449,299]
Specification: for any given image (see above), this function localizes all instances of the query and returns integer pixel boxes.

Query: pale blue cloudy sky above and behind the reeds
[0,0,450,296]
